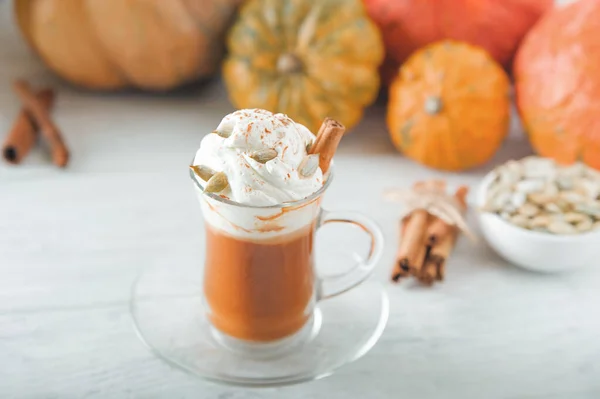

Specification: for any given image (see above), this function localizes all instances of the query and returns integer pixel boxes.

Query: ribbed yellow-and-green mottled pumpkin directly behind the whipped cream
[223,0,384,132]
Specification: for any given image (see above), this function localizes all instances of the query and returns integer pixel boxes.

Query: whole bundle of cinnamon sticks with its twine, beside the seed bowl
[384,180,476,285]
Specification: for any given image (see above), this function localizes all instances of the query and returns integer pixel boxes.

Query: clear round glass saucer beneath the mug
[130,264,389,386]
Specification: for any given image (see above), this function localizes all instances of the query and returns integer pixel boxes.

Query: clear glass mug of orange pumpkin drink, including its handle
[191,171,383,352]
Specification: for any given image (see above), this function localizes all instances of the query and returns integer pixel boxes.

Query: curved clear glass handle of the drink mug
[317,210,383,300]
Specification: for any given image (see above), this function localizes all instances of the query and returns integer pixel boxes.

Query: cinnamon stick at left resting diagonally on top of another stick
[13,80,69,167]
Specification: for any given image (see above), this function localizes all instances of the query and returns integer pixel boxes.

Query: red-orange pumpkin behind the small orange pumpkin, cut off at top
[364,0,553,78]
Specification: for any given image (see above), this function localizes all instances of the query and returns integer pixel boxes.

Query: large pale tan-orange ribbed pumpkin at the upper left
[15,0,239,90]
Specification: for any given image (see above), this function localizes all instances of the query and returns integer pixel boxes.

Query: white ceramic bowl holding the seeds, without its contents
[475,172,600,273]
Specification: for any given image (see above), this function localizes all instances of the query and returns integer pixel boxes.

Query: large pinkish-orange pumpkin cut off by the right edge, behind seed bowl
[514,0,600,169]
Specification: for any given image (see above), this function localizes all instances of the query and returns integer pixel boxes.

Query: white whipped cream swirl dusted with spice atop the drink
[194,109,323,206]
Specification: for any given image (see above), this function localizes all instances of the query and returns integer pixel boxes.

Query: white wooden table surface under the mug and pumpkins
[0,1,600,399]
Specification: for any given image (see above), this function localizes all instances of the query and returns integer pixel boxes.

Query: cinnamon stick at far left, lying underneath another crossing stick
[2,89,54,164]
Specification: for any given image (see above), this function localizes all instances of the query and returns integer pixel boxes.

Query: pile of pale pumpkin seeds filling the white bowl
[482,156,600,234]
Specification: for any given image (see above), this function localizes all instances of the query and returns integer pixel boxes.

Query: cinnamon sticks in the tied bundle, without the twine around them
[392,181,469,285]
